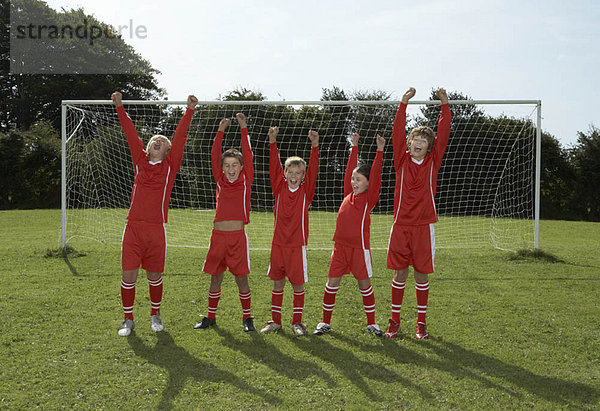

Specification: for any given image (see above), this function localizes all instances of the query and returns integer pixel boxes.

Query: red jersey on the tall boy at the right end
[392,103,450,225]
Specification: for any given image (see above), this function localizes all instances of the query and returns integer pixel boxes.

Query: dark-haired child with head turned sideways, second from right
[313,133,385,337]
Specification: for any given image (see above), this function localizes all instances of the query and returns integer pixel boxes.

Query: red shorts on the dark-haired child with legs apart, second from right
[327,244,373,280]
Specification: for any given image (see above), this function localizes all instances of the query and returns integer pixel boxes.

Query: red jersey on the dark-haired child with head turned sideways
[333,146,383,250]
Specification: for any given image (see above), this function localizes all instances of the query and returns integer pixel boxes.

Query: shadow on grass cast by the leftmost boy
[127,331,281,410]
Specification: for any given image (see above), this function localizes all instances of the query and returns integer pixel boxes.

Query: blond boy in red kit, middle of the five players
[260,127,319,335]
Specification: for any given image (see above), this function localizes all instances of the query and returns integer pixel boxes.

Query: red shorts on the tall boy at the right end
[388,224,435,274]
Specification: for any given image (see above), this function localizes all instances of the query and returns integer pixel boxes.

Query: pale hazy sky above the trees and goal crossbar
[46,0,600,147]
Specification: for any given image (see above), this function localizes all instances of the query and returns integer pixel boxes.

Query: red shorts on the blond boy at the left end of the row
[121,221,167,273]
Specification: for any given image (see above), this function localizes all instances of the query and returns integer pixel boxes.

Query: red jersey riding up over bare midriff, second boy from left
[210,128,254,224]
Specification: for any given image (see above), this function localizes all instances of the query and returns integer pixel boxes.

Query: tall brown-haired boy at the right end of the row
[385,87,451,340]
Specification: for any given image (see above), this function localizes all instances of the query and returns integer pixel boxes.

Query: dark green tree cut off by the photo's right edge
[570,125,600,221]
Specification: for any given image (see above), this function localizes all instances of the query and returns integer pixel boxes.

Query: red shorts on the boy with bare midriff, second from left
[202,230,250,277]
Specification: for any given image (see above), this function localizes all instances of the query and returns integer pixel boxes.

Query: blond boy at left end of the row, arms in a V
[111,91,198,337]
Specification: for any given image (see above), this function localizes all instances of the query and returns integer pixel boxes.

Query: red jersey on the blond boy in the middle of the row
[269,143,319,247]
